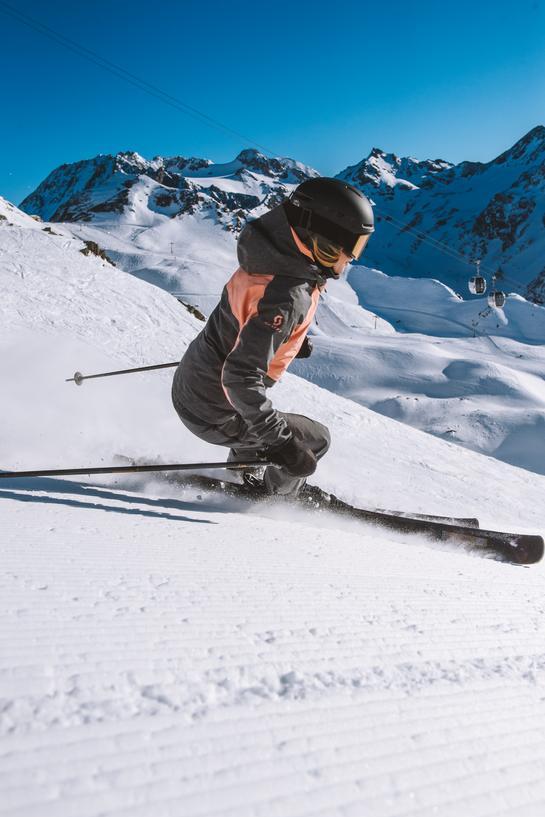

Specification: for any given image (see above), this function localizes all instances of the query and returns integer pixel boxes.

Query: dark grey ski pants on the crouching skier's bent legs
[176,407,331,496]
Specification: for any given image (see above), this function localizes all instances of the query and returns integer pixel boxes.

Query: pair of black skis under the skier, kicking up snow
[124,466,544,565]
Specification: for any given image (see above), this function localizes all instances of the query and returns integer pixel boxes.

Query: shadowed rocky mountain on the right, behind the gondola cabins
[338,126,545,302]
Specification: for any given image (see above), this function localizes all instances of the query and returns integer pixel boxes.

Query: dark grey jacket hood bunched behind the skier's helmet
[237,204,326,284]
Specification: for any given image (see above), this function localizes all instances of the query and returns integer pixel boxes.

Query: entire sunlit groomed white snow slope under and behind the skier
[0,199,545,817]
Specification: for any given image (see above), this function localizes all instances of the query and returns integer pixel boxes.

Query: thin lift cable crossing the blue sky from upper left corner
[0,0,278,156]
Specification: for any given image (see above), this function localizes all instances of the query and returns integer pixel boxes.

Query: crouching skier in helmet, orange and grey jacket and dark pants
[172,178,374,496]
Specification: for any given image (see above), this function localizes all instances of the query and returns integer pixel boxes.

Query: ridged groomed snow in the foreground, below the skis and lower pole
[0,482,545,817]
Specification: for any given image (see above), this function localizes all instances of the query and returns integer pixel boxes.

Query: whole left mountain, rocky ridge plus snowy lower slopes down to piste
[21,150,318,302]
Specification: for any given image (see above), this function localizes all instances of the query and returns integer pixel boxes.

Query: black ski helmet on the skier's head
[284,177,375,258]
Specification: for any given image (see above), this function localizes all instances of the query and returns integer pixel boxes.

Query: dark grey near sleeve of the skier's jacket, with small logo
[222,285,295,446]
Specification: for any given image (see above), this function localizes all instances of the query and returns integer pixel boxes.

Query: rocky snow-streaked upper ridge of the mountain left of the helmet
[21,150,318,231]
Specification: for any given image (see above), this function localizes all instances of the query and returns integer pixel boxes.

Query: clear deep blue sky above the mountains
[0,0,545,203]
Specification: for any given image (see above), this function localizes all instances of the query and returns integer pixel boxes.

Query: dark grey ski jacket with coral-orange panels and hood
[172,205,326,446]
